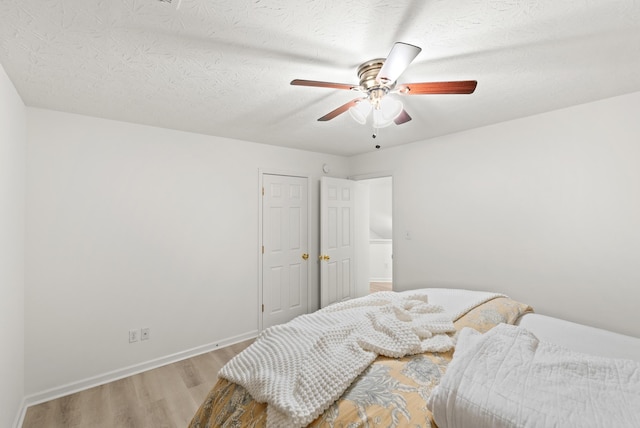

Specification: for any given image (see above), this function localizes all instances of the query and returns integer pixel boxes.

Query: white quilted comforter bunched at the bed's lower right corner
[428,324,640,428]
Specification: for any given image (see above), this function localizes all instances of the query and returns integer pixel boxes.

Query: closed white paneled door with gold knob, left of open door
[262,174,309,329]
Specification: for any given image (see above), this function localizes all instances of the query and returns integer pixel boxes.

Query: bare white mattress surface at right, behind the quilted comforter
[518,314,640,361]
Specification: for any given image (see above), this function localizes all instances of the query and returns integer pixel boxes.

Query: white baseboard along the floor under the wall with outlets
[22,330,258,410]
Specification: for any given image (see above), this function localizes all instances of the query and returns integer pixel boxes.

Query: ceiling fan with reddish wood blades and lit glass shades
[291,42,478,132]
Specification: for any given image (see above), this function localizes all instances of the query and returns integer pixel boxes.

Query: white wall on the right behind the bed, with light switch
[350,93,640,337]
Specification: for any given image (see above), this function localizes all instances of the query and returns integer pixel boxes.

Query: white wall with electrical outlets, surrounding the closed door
[25,108,348,398]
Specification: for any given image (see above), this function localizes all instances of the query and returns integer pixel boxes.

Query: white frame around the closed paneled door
[256,168,317,332]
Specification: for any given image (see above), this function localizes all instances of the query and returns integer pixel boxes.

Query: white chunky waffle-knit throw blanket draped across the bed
[219,291,496,427]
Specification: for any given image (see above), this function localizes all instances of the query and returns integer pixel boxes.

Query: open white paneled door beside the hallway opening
[319,177,357,308]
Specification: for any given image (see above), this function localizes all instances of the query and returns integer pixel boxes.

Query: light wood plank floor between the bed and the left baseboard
[22,341,252,428]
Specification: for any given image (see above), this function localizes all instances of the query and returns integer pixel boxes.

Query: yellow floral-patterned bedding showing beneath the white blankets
[189,297,532,428]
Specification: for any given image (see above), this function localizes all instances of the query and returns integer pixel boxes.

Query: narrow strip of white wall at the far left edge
[0,65,27,427]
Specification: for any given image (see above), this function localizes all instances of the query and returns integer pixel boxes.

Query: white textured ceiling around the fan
[0,0,640,155]
